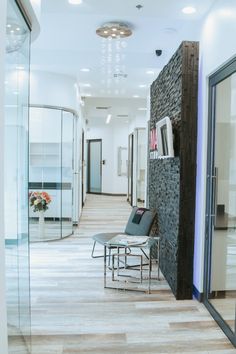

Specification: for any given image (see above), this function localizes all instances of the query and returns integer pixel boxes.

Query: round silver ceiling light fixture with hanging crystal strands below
[96,22,132,39]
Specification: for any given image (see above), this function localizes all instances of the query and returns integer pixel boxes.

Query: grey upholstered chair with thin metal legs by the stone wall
[91,207,155,258]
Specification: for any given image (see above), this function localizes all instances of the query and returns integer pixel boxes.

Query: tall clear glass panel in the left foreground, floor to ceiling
[4,0,30,354]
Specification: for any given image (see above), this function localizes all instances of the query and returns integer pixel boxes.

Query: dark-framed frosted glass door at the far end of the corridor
[88,139,102,194]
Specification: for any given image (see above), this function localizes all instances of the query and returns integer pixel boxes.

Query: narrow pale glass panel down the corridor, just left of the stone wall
[136,128,147,207]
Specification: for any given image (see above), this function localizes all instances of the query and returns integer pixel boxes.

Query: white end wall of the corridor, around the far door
[86,122,128,194]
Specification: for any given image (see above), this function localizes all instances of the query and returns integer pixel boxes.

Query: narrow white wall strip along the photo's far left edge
[0,0,8,354]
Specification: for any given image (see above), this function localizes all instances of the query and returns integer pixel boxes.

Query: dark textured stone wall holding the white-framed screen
[148,42,198,299]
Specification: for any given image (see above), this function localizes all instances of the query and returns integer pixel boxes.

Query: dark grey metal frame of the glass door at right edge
[203,57,236,346]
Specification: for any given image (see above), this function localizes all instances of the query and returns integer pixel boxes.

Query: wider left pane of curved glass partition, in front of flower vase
[29,107,61,241]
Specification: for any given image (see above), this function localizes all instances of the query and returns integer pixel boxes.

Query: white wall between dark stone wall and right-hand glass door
[194,0,236,292]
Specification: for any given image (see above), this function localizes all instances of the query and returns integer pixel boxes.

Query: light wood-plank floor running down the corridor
[12,195,236,354]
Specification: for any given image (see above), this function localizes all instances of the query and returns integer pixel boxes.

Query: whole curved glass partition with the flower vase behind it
[29,106,76,242]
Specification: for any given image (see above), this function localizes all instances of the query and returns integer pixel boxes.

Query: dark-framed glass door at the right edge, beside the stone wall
[205,61,236,344]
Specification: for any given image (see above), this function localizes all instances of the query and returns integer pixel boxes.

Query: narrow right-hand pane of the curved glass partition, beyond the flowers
[61,112,74,237]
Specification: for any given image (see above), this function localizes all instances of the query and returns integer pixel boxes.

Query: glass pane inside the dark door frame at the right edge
[209,74,236,331]
